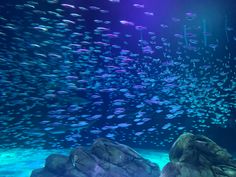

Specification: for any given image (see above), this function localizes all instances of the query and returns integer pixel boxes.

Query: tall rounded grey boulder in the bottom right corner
[161,133,236,177]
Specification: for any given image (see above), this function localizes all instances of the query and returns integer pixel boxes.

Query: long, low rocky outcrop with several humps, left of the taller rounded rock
[31,139,160,177]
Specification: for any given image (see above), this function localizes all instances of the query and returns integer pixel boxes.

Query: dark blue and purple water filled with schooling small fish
[0,0,236,152]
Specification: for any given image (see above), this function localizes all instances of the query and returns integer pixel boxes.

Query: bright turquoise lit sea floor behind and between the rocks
[0,149,169,177]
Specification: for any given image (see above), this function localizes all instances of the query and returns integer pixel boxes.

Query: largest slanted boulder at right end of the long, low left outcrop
[91,139,160,177]
